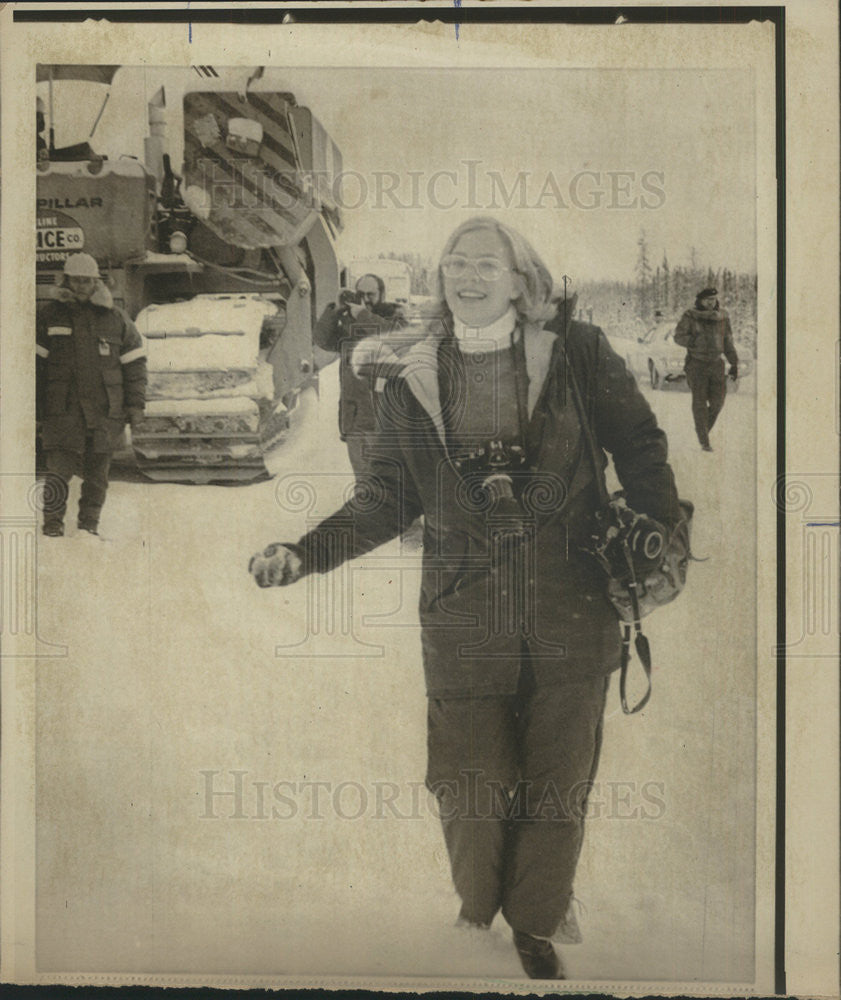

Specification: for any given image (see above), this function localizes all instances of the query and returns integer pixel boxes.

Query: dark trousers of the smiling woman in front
[426,662,608,937]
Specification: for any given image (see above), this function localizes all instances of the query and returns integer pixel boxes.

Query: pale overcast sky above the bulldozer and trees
[39,66,756,281]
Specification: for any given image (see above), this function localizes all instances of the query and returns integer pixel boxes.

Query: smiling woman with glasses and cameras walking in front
[249,216,680,979]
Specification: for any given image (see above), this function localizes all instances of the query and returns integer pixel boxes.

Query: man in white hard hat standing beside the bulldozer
[35,253,146,537]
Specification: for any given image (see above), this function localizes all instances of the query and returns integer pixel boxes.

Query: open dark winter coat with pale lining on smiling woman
[298,323,679,697]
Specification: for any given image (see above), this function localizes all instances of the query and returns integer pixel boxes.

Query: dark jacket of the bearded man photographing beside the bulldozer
[313,302,403,441]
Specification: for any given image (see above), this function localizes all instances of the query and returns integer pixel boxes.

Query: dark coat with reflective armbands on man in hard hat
[36,282,146,455]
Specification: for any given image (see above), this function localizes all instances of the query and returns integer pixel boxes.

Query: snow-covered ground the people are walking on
[36,365,756,989]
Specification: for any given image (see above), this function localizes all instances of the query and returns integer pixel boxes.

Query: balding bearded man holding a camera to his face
[313,274,406,479]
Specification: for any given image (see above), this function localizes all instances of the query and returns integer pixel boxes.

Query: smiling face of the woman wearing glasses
[444,229,520,326]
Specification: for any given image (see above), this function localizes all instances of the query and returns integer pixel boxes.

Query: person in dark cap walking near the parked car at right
[675,288,739,451]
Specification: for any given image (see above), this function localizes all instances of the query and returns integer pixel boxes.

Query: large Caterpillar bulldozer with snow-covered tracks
[36,65,342,483]
